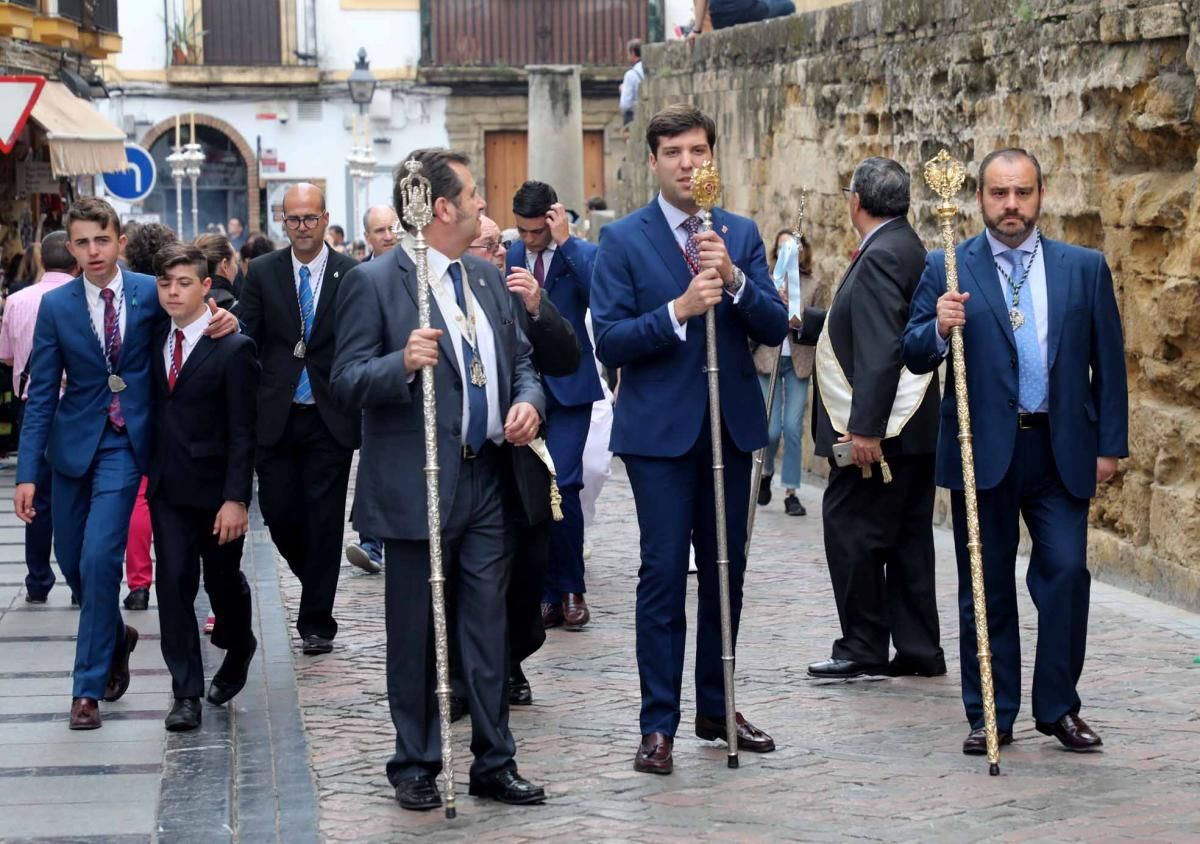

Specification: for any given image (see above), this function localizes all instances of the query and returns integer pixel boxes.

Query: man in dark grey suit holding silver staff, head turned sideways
[332,150,545,810]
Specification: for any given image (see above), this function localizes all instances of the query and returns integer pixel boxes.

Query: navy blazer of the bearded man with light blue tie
[904,234,1129,498]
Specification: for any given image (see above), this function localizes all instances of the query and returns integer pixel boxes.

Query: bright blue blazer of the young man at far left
[17,271,168,484]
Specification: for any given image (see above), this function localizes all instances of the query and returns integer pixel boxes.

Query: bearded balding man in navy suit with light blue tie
[904,149,1129,755]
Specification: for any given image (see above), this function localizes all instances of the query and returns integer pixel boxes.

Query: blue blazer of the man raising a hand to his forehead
[505,237,604,407]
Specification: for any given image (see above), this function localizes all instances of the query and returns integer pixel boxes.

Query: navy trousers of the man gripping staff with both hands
[622,417,751,736]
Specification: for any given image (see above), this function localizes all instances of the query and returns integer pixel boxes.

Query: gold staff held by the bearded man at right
[925,149,1000,777]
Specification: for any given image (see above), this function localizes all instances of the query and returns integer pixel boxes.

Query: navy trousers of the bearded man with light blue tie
[950,429,1092,732]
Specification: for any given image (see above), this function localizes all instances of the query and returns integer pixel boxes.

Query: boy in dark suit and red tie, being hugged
[146,244,259,731]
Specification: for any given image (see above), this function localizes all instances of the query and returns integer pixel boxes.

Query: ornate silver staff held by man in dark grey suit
[400,158,456,818]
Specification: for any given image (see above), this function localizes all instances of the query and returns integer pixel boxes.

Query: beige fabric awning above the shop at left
[30,82,127,176]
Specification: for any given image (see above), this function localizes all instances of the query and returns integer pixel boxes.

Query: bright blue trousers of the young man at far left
[52,426,142,700]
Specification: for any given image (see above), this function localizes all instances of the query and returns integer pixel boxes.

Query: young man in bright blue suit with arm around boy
[13,197,238,730]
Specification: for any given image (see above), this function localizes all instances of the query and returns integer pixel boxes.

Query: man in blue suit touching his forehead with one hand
[506,181,604,630]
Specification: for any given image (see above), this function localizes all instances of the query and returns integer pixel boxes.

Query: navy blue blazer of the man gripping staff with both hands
[592,199,787,457]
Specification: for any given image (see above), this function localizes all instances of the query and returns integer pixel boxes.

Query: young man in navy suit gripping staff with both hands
[592,106,787,773]
